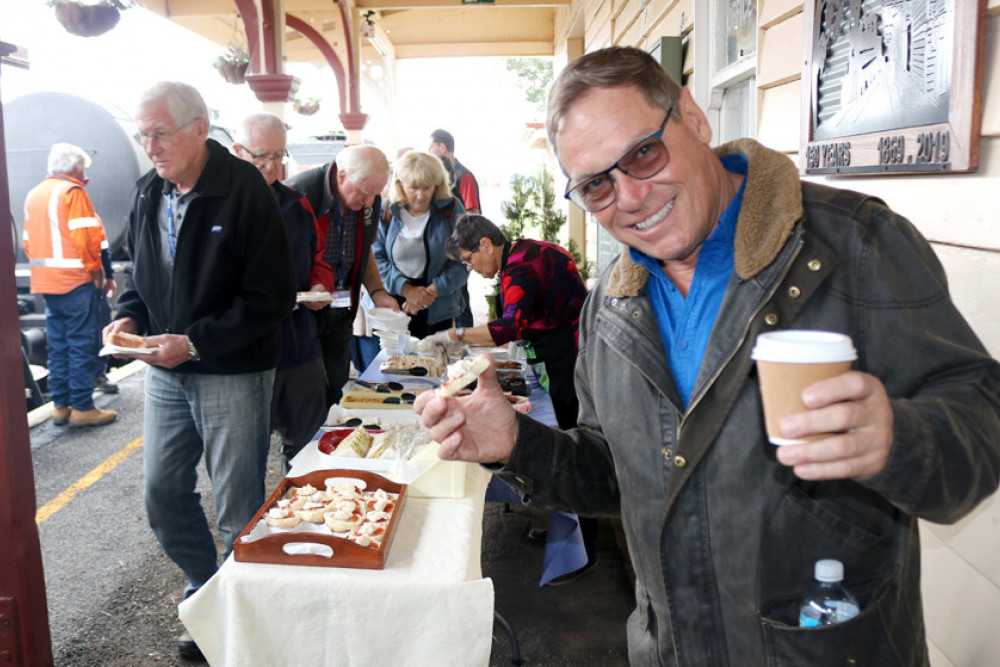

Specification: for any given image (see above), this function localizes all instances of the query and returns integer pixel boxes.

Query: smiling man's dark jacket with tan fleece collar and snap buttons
[498,140,1000,667]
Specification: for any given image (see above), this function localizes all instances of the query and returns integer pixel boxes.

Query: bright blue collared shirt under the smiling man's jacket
[629,153,748,407]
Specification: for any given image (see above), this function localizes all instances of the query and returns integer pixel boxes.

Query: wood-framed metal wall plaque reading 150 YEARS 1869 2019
[800,0,986,174]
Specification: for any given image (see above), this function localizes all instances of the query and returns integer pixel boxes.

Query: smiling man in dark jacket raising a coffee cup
[415,47,1000,667]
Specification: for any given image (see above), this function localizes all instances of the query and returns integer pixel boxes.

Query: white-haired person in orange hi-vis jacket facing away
[24,143,117,426]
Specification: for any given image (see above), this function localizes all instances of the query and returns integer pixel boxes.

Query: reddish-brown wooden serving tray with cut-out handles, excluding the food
[233,469,406,570]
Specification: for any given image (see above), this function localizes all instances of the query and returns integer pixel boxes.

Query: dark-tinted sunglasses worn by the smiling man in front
[564,107,674,213]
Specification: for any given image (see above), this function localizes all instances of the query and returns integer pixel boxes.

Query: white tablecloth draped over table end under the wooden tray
[179,465,493,667]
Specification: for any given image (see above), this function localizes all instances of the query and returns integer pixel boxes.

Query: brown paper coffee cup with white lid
[751,329,858,445]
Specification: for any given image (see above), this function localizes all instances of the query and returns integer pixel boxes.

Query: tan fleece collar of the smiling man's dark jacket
[607,139,802,297]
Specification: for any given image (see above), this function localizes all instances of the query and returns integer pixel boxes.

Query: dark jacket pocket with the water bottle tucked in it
[758,482,927,667]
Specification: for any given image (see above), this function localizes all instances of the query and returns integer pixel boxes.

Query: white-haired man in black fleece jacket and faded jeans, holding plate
[105,82,296,657]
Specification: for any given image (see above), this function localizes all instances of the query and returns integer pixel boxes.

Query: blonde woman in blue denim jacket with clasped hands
[372,151,468,338]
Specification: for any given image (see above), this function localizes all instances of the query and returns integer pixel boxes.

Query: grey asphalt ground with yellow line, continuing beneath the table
[30,364,633,667]
